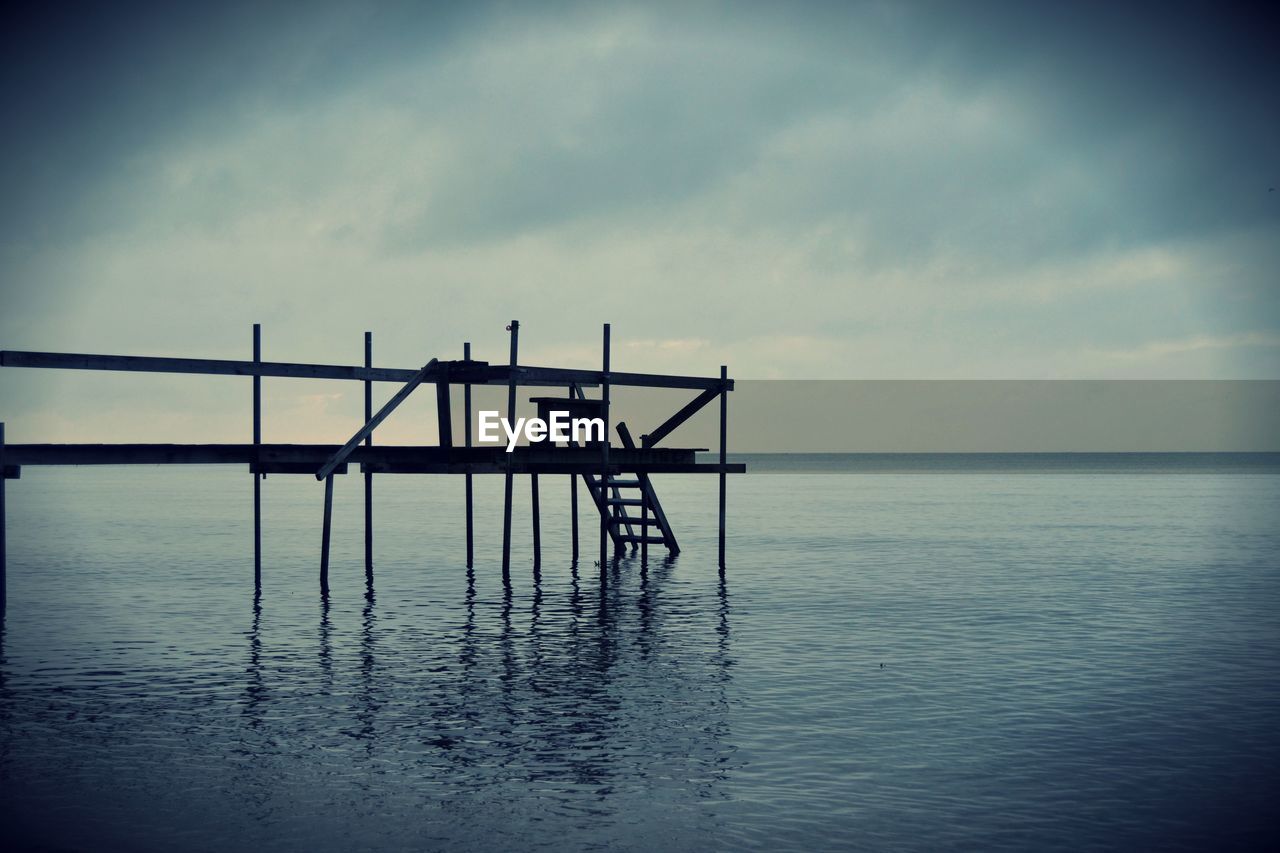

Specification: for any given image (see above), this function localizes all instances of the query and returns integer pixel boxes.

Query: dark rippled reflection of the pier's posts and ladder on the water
[259,558,732,811]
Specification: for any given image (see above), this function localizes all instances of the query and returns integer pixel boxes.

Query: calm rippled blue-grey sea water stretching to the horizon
[0,455,1280,850]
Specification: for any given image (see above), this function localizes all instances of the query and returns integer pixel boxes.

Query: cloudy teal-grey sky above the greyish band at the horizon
[0,3,1280,441]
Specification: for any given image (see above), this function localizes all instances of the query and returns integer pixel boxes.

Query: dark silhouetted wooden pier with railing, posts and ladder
[0,320,746,608]
